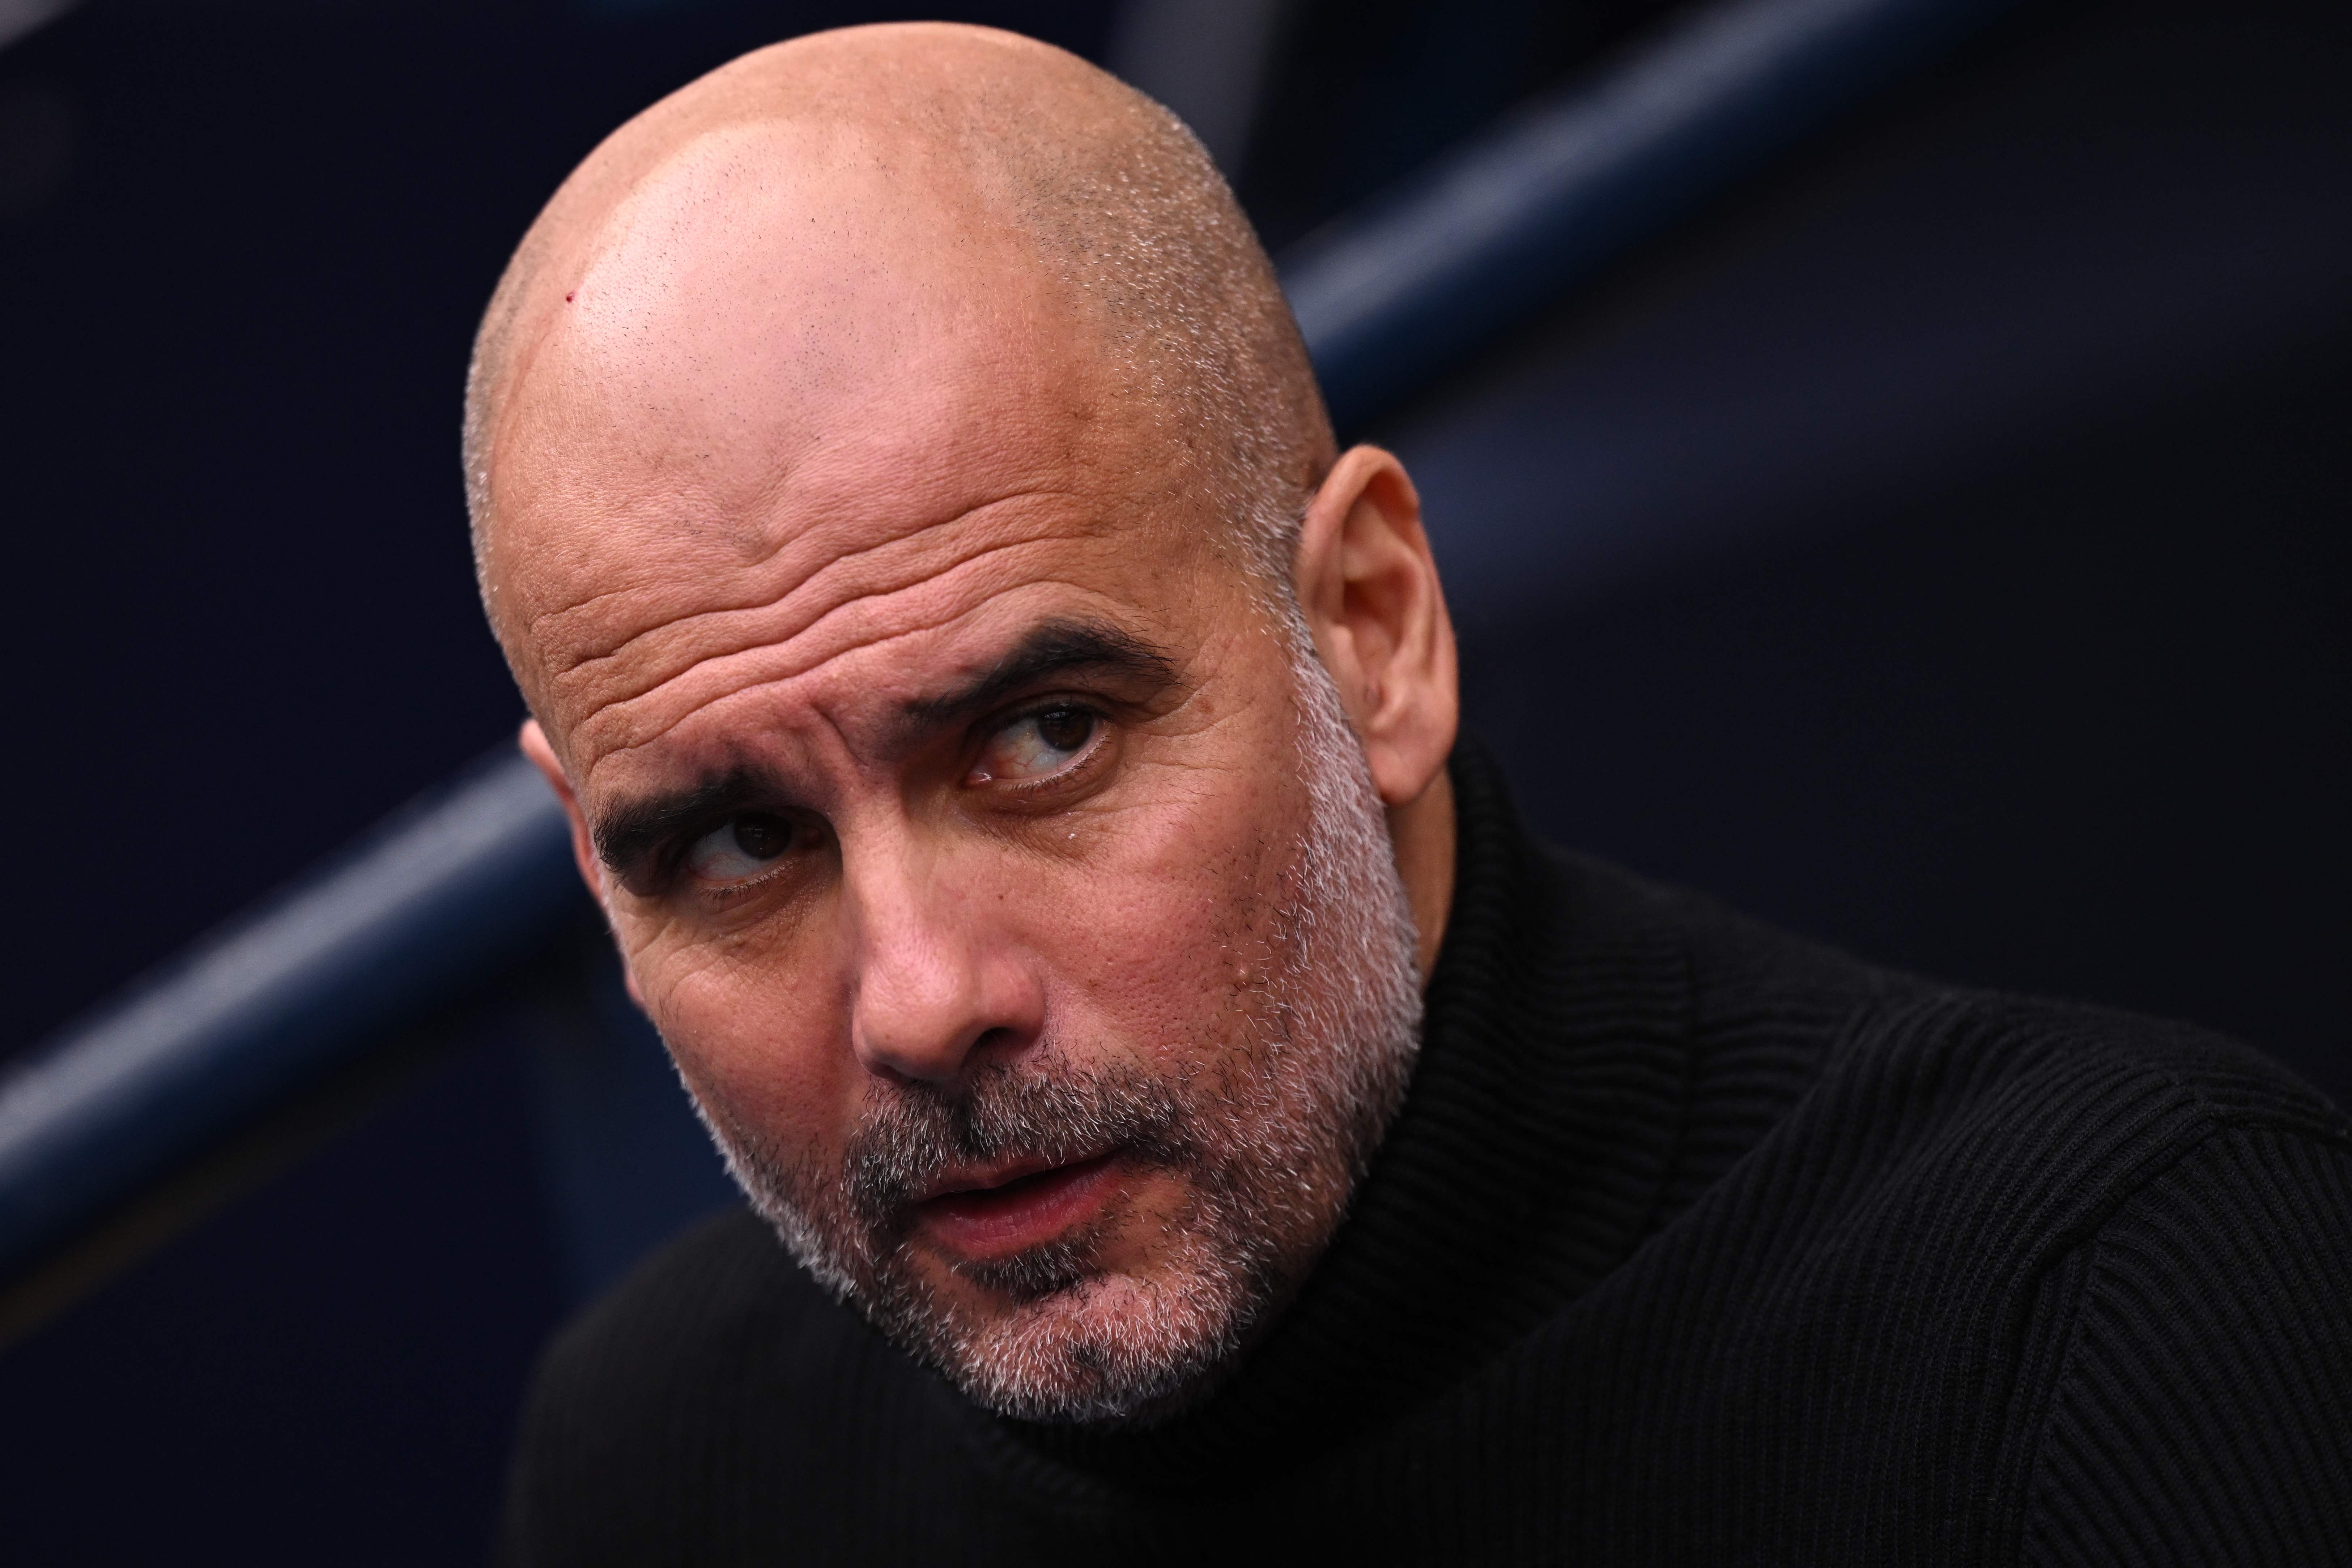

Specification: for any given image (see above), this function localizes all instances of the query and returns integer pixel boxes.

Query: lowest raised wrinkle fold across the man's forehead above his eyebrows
[574,538,1108,757]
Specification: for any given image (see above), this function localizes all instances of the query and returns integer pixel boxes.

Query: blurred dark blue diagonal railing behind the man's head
[0,0,2011,1321]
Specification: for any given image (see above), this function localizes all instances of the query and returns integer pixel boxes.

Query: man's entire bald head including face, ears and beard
[451,26,1456,1420]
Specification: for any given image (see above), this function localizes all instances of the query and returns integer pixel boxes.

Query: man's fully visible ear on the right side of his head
[1296,447,1460,806]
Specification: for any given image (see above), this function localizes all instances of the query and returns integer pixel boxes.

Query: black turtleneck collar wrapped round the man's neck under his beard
[957,738,1691,1493]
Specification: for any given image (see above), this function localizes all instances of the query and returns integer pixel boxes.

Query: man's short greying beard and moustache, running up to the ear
[698,644,1421,1422]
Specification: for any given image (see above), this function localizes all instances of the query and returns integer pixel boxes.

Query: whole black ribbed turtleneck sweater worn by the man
[503,747,2352,1568]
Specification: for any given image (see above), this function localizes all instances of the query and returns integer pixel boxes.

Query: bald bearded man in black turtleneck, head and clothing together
[466,26,2352,1563]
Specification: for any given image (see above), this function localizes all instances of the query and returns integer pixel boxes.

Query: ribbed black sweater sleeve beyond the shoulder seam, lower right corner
[2020,1121,2352,1563]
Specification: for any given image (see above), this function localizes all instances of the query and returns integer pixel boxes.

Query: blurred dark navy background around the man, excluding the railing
[0,0,2352,1563]
